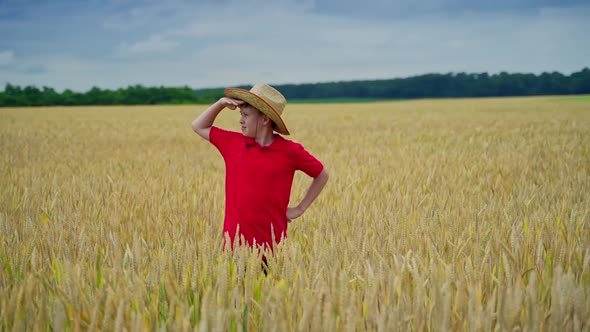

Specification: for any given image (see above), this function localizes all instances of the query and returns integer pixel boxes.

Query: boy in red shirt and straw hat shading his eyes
[192,83,328,250]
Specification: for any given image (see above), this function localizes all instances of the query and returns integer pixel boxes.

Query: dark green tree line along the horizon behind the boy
[0,68,590,107]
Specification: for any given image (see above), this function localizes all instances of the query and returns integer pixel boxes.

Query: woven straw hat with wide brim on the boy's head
[224,83,290,135]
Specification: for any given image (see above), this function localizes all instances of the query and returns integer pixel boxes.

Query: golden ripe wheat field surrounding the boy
[0,97,590,331]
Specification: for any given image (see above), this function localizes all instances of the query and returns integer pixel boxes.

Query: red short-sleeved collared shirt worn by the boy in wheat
[209,127,324,249]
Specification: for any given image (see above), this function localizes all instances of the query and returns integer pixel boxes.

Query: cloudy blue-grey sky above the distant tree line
[0,0,590,91]
